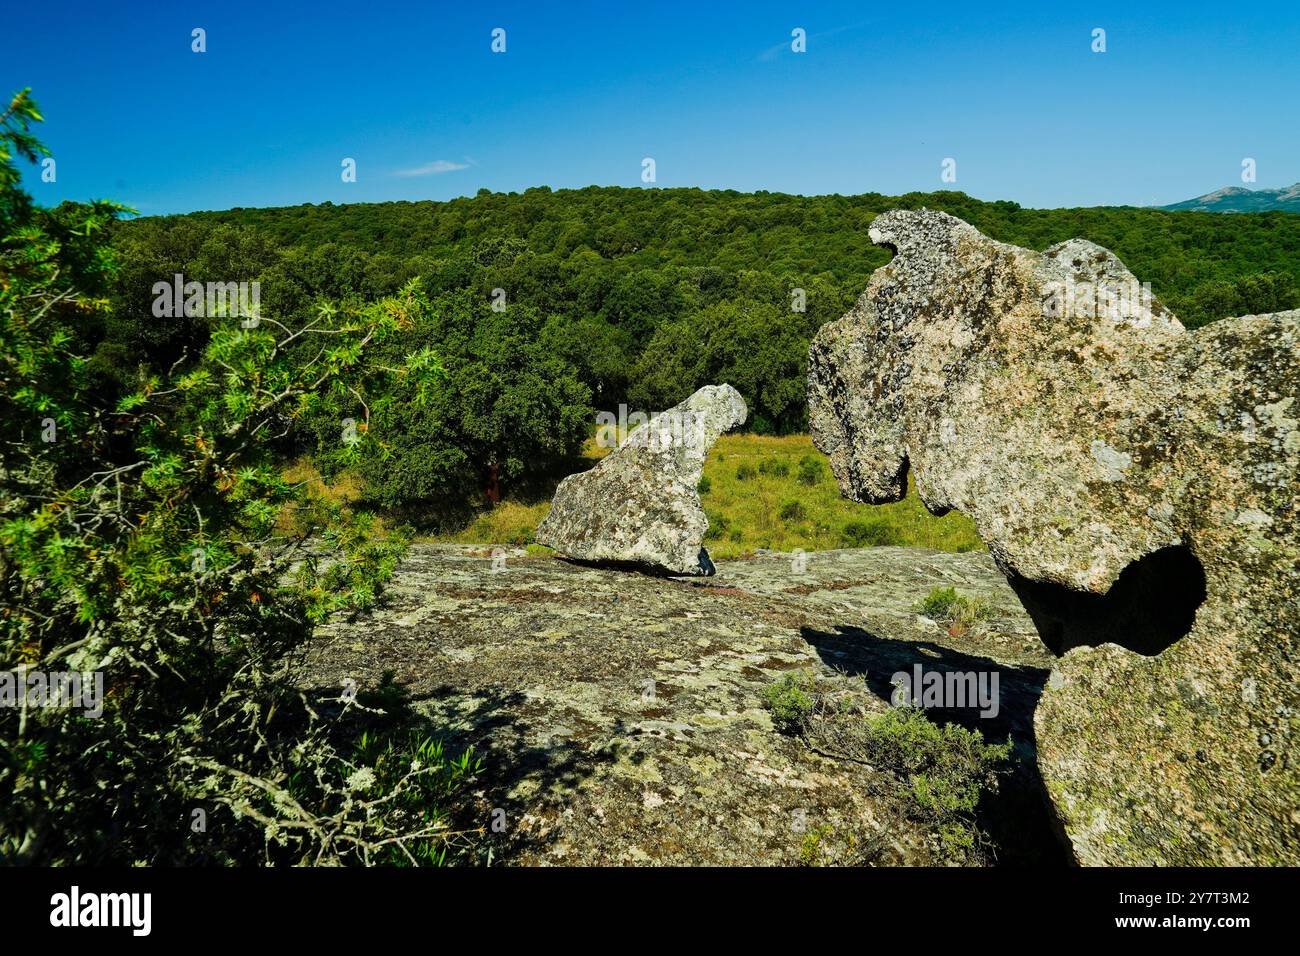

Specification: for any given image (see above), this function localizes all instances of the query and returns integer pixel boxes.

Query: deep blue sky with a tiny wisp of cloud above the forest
[0,0,1300,215]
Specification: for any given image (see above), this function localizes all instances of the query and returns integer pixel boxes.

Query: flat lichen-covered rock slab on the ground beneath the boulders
[306,545,1065,865]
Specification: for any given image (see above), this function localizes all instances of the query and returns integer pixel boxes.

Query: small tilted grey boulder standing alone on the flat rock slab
[537,385,746,575]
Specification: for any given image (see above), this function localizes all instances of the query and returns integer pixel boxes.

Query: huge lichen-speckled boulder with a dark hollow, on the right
[809,211,1300,865]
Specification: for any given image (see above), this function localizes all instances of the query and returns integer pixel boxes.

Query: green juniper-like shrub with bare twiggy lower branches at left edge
[0,92,476,865]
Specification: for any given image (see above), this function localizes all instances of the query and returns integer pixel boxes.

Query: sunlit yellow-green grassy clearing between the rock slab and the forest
[287,434,984,558]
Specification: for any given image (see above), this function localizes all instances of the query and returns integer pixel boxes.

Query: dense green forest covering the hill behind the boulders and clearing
[96,187,1300,505]
